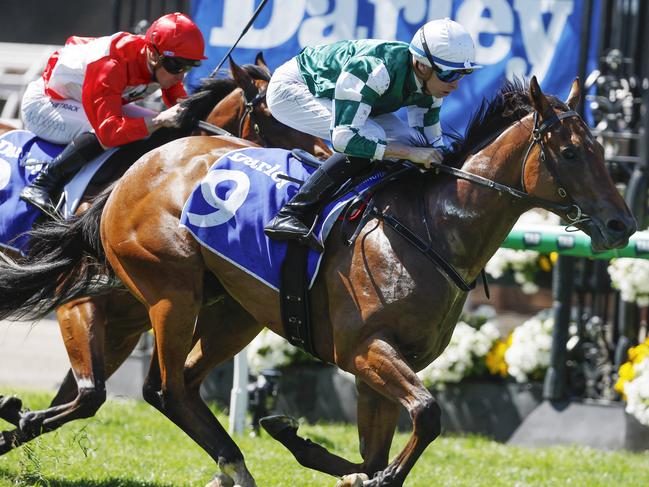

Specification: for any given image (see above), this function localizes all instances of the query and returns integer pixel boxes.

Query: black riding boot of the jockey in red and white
[20,132,104,213]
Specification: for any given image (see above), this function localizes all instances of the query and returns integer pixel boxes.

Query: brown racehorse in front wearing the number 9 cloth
[0,78,635,487]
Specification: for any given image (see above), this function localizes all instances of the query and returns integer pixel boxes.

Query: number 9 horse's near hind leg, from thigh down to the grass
[114,254,256,487]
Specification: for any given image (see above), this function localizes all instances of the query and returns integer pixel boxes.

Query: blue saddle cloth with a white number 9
[180,148,382,290]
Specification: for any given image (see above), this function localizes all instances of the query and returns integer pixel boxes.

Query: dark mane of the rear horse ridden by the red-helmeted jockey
[173,64,270,131]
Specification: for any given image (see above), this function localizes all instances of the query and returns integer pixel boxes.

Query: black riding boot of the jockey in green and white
[264,154,369,252]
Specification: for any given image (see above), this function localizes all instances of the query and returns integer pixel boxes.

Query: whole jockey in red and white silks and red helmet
[21,13,205,211]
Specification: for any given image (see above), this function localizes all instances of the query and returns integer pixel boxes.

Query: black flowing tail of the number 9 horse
[0,188,114,319]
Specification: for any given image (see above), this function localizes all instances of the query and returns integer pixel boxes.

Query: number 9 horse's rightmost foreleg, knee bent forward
[350,337,441,487]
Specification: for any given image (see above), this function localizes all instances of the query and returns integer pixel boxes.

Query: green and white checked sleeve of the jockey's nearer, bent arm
[331,56,390,160]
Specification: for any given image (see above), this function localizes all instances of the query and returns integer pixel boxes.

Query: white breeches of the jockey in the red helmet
[20,78,157,144]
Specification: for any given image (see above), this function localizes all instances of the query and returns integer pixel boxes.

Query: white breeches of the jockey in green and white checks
[266,58,428,150]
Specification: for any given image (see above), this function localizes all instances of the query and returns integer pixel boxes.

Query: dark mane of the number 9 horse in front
[444,79,569,167]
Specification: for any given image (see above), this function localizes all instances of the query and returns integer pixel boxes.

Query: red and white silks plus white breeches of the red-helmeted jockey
[22,32,186,147]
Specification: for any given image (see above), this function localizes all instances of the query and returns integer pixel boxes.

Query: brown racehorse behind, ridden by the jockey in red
[0,55,329,454]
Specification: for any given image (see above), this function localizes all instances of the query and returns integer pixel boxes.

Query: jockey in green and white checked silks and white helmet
[265,19,481,251]
